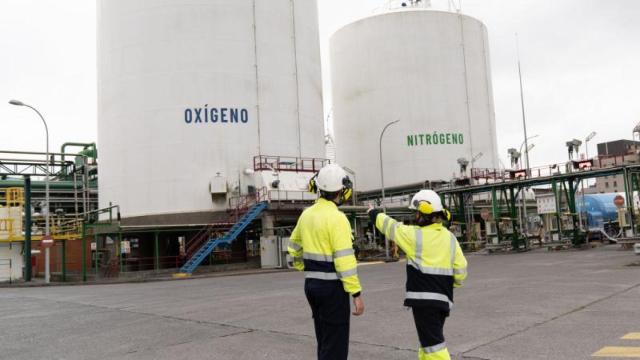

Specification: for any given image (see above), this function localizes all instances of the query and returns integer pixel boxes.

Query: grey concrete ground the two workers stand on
[0,246,640,360]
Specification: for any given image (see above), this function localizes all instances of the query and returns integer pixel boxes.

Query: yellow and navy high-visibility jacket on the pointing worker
[376,213,467,310]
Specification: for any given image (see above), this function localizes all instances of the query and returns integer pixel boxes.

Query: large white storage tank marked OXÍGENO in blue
[97,0,324,217]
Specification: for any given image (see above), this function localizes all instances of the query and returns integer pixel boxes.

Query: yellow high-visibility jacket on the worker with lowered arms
[287,198,361,295]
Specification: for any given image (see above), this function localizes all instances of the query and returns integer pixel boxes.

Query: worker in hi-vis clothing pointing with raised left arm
[369,190,467,360]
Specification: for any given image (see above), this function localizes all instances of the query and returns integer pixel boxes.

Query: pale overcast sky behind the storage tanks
[0,0,640,166]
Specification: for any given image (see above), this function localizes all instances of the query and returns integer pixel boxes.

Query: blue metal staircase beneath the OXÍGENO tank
[177,201,268,276]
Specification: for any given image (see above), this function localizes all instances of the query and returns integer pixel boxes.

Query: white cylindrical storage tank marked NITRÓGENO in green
[330,4,498,191]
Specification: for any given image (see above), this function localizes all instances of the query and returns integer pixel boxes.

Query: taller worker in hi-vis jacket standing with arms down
[288,164,364,360]
